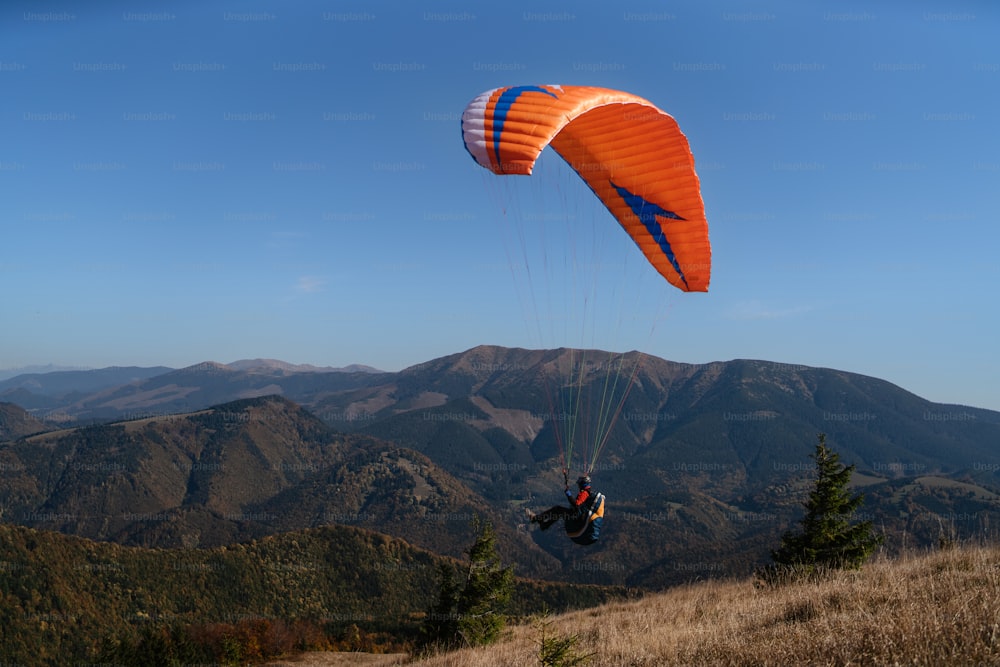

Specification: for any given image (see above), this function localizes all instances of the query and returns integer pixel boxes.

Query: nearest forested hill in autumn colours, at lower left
[0,525,622,665]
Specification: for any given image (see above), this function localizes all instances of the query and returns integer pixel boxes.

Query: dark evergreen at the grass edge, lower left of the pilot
[420,517,514,649]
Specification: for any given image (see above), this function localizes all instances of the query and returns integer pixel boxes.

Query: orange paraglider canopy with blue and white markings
[462,86,712,292]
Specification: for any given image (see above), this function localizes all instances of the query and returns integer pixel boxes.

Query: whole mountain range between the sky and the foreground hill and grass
[0,346,1000,587]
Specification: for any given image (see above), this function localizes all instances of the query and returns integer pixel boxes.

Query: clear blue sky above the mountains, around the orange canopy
[0,0,1000,409]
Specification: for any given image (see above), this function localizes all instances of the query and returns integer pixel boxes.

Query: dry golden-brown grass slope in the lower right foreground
[407,546,1000,667]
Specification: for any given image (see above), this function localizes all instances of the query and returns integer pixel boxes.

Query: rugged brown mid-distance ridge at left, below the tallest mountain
[0,397,552,575]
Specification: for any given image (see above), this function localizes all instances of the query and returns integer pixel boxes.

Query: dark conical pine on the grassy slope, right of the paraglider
[762,433,884,581]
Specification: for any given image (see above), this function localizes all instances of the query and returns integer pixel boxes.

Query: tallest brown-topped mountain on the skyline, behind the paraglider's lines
[322,347,1000,498]
